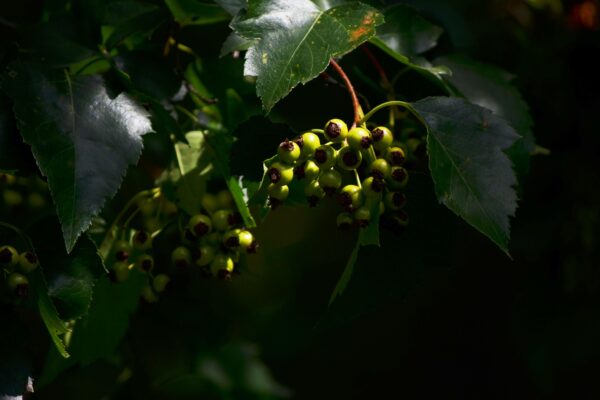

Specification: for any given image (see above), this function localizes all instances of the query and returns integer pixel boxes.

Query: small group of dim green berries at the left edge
[0,245,39,298]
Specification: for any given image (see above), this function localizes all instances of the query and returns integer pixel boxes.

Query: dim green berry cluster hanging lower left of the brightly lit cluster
[108,190,258,303]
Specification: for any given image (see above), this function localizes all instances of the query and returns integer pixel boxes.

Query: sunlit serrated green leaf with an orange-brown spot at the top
[232,0,383,111]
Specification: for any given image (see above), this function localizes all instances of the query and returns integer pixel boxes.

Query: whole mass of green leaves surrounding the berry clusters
[0,0,534,394]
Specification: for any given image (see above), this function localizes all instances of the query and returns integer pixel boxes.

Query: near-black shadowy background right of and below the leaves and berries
[3,0,600,399]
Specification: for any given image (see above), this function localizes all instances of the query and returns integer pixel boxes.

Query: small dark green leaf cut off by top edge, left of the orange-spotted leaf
[165,0,230,26]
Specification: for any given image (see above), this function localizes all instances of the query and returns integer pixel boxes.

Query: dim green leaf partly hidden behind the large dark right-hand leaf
[436,55,535,175]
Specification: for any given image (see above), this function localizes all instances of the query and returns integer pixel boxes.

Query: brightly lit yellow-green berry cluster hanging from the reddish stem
[266,119,408,228]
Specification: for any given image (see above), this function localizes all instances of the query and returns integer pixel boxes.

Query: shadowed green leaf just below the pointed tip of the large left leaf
[28,218,105,320]
